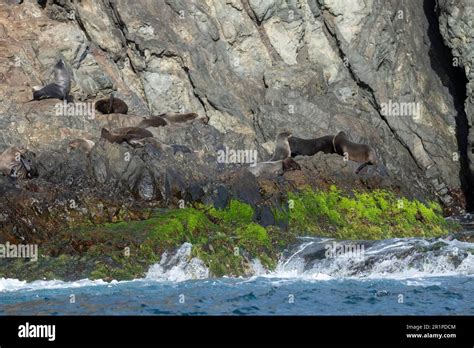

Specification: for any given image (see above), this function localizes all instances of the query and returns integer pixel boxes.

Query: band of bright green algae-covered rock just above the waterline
[0,186,458,280]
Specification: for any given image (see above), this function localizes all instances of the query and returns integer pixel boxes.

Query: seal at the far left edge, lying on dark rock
[0,146,38,180]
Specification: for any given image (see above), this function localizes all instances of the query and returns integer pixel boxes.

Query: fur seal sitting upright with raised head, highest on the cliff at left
[33,59,72,102]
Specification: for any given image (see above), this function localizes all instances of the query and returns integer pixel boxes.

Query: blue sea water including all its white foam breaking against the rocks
[0,238,474,315]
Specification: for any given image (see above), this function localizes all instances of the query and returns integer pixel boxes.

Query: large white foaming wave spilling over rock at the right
[264,238,474,280]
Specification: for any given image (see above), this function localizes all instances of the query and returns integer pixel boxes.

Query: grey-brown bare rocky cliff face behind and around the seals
[0,0,473,237]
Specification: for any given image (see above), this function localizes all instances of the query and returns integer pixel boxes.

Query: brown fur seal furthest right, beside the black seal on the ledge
[333,132,378,174]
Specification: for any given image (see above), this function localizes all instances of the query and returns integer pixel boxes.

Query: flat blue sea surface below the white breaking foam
[0,276,474,315]
